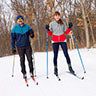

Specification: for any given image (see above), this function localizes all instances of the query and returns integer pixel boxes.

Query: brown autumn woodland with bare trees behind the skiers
[0,0,96,57]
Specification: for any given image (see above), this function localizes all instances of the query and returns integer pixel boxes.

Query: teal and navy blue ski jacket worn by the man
[11,24,34,48]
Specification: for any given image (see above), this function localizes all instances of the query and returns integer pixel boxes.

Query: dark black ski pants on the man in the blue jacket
[17,46,33,74]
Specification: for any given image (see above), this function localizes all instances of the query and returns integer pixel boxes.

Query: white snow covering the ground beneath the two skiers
[0,48,96,96]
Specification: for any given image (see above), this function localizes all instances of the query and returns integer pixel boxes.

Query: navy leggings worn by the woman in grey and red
[53,42,71,66]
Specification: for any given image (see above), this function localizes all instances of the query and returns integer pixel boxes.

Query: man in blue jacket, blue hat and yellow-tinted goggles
[11,15,34,79]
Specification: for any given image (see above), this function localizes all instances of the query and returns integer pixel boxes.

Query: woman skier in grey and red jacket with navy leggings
[46,11,75,76]
